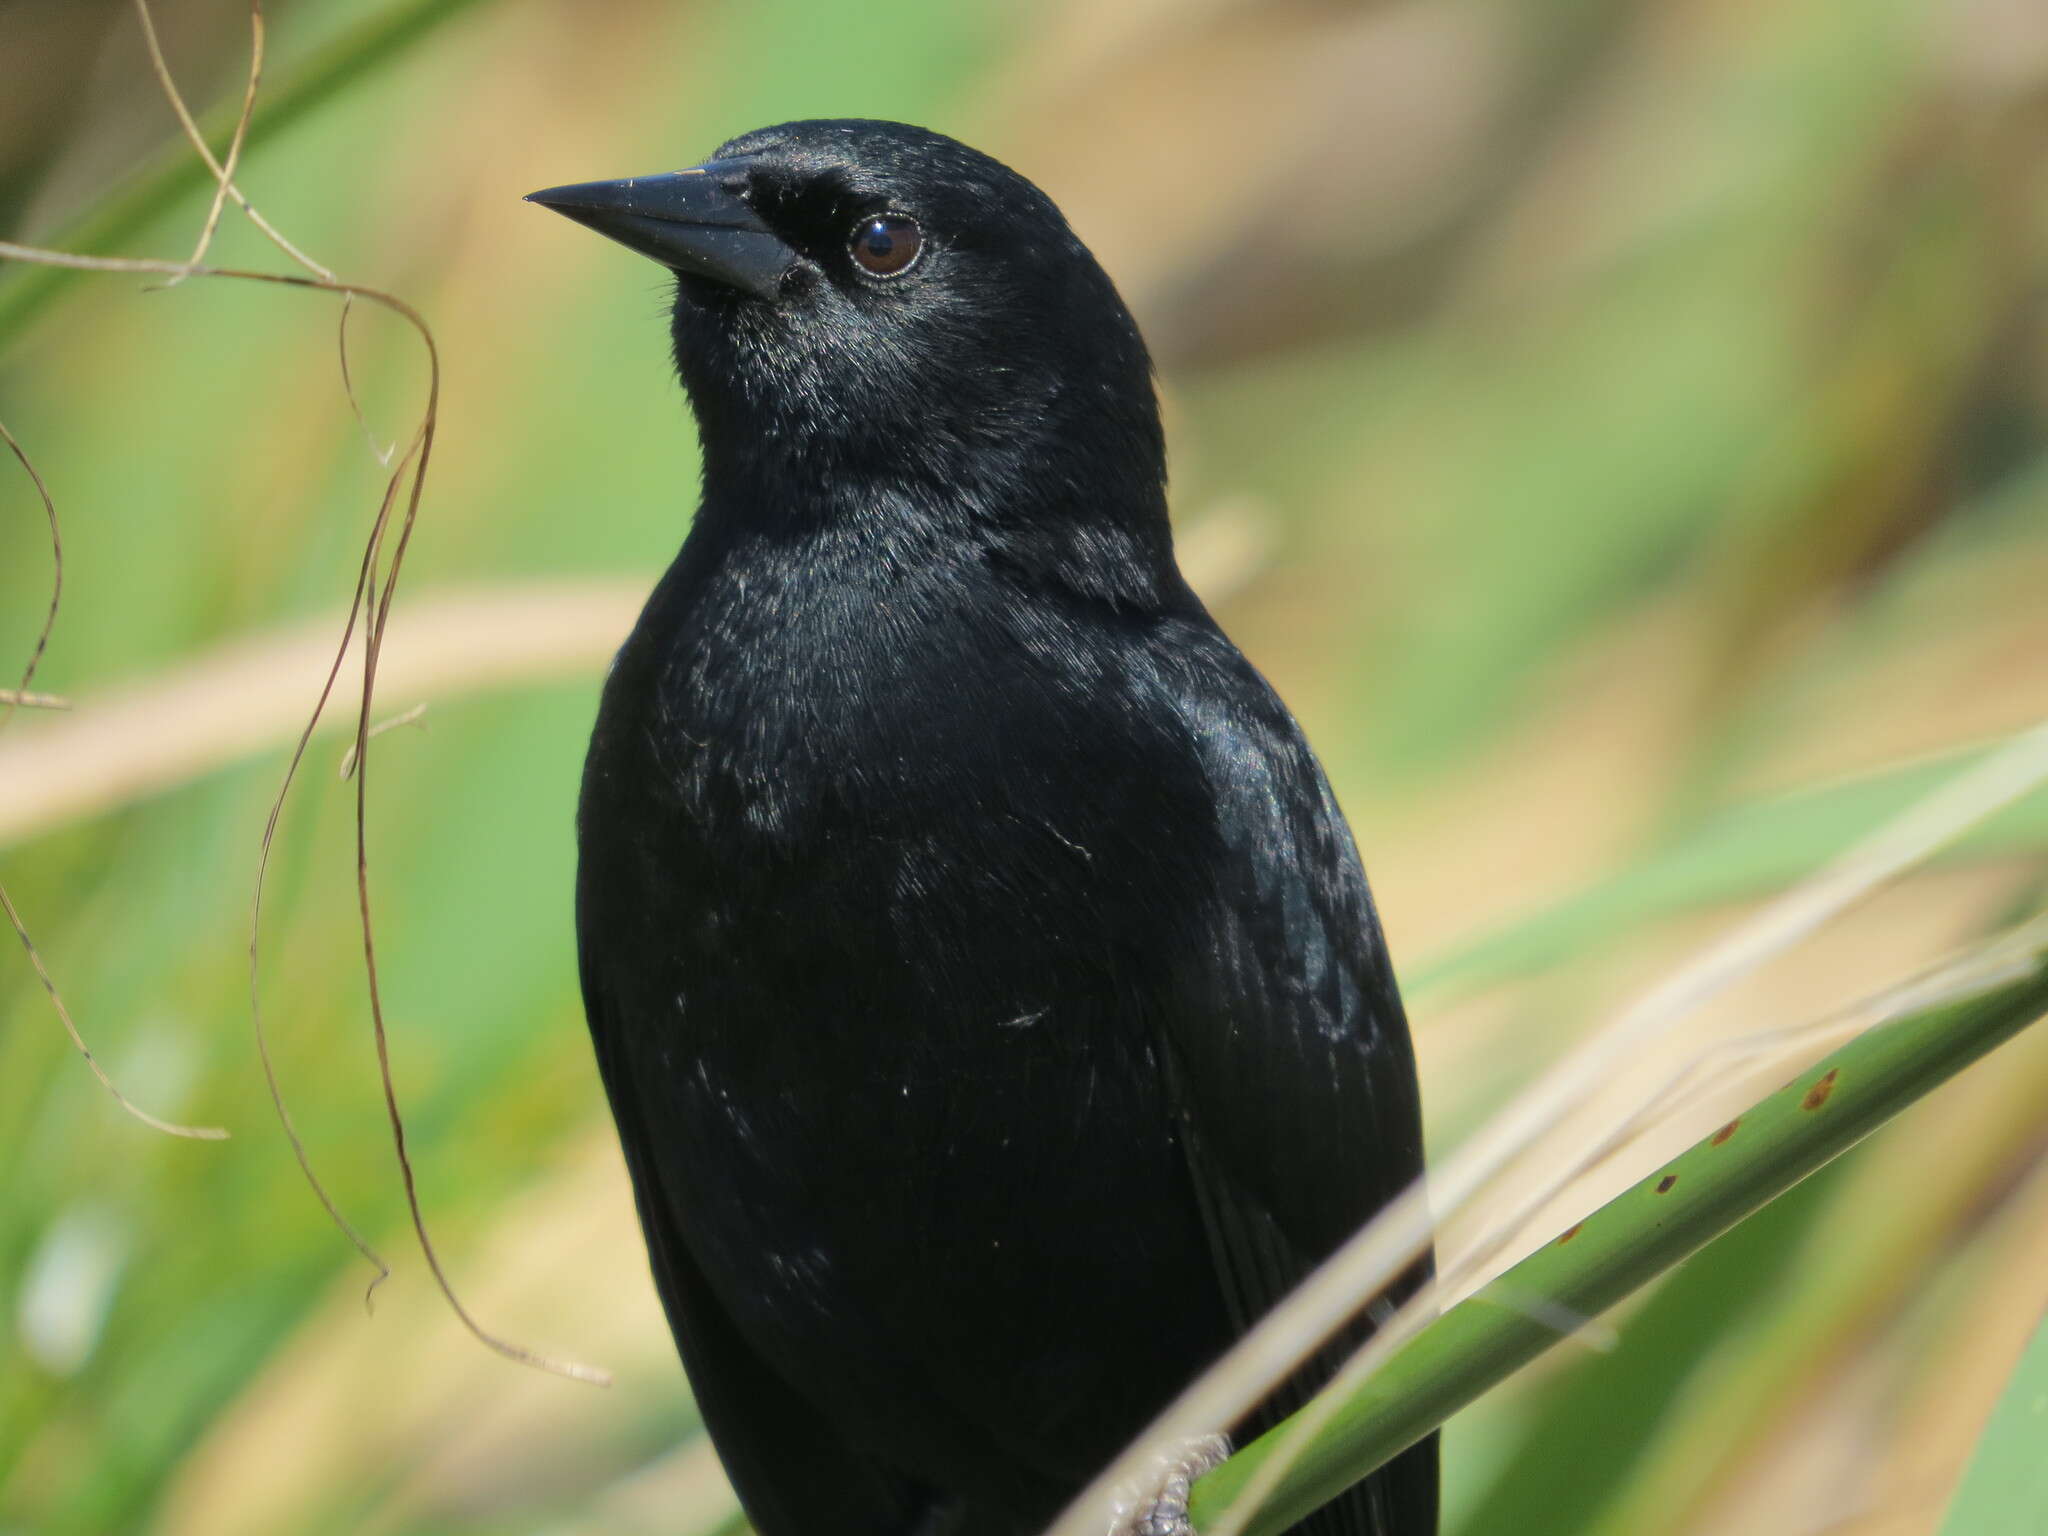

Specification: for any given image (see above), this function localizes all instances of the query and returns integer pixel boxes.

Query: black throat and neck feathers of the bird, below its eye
[676,301,1184,612]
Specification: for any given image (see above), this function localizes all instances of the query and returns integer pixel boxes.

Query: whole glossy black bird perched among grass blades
[532,121,1436,1536]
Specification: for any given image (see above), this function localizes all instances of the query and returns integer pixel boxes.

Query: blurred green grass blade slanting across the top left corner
[0,0,491,352]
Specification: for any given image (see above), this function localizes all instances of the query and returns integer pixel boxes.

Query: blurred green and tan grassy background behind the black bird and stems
[0,0,2048,1536]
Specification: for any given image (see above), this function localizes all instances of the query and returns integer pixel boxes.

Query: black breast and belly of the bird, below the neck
[582,552,1245,1482]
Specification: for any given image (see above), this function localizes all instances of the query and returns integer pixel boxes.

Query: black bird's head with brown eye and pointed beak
[530,121,1163,524]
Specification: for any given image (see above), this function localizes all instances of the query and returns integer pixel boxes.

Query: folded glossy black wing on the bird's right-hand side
[1161,637,1438,1536]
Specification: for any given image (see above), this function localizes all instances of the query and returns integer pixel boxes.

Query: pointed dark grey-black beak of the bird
[526,160,797,299]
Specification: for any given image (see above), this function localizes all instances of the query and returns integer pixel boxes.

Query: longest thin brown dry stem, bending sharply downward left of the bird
[0,234,610,1384]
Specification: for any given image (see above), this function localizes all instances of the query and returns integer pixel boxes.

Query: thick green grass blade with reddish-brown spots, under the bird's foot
[1192,946,2048,1536]
